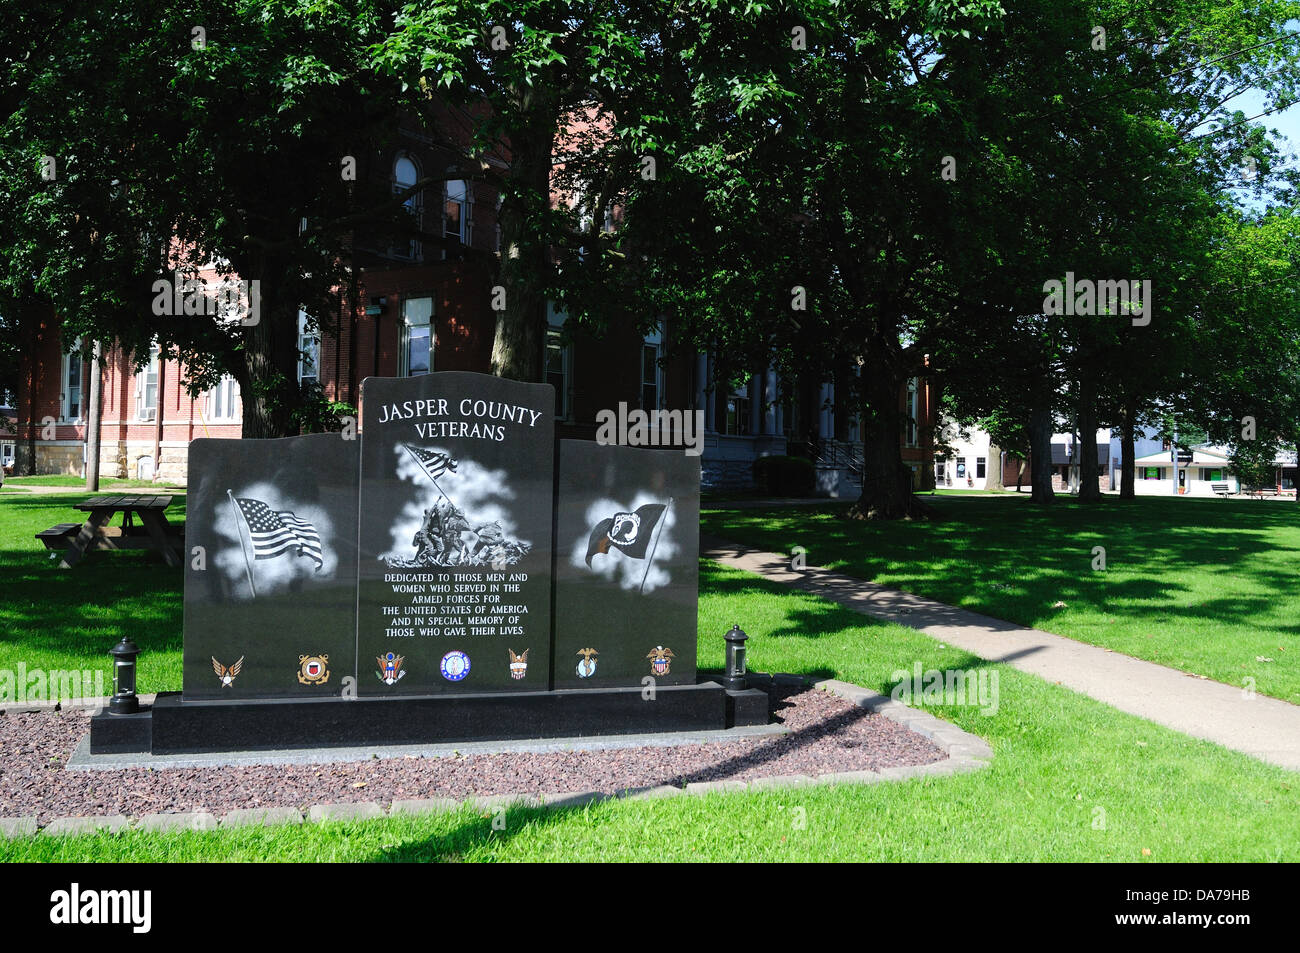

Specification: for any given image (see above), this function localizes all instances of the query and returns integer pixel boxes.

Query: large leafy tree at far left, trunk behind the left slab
[0,0,406,437]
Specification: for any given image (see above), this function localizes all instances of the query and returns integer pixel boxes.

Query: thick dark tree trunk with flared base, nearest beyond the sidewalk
[849,342,928,520]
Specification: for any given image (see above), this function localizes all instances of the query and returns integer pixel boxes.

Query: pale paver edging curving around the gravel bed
[0,672,993,839]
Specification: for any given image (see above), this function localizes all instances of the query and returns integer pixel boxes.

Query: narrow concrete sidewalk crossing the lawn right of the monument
[699,536,1300,771]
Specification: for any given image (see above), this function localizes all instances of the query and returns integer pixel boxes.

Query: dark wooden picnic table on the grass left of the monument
[36,494,185,569]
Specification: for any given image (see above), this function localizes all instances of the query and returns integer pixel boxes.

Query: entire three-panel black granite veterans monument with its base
[91,372,768,754]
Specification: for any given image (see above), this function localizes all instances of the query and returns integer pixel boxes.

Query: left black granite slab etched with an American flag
[182,433,360,701]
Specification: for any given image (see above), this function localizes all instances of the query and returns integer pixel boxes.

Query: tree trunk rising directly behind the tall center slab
[490,79,559,381]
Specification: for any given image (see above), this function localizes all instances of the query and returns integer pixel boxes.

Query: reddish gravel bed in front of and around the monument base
[0,688,946,824]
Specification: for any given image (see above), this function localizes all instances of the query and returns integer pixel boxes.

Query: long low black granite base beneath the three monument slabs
[90,680,768,754]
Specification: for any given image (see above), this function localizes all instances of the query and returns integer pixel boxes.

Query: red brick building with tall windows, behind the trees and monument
[0,113,933,489]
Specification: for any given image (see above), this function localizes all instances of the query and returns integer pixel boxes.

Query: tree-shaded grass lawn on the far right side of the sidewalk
[702,494,1300,703]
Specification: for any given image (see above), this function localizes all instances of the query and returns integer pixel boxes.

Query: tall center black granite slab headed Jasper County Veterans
[358,372,555,696]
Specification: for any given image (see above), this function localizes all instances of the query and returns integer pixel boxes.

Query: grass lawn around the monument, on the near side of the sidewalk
[0,495,1300,861]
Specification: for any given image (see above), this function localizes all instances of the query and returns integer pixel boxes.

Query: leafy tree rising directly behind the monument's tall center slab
[374,0,670,381]
